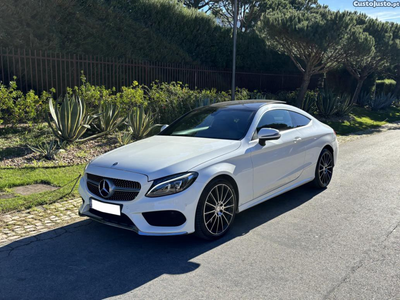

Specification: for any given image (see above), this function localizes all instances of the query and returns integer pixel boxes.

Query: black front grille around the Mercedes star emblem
[86,173,141,201]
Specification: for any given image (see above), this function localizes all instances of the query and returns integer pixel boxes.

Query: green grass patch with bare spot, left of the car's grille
[0,165,84,214]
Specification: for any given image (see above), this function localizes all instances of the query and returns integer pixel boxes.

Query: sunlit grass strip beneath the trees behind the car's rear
[324,107,400,135]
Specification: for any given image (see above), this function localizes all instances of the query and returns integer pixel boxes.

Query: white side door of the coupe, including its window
[251,109,305,198]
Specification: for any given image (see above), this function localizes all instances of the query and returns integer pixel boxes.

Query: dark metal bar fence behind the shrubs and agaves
[0,48,317,94]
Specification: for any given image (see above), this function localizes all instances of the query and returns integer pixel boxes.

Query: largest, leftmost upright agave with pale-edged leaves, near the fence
[48,95,99,142]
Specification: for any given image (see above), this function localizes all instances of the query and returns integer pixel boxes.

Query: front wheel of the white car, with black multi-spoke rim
[195,178,238,240]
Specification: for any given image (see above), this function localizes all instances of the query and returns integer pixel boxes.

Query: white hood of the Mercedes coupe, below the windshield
[90,135,240,181]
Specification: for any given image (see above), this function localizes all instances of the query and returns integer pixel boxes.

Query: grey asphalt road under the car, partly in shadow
[0,130,400,300]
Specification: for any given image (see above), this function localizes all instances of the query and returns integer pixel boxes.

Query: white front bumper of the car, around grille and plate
[79,168,203,236]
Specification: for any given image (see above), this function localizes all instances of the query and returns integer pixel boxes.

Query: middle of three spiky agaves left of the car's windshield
[93,102,126,133]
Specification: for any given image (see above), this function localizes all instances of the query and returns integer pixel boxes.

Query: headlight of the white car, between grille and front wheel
[146,172,199,197]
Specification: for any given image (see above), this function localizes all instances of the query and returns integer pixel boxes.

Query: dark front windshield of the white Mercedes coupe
[160,106,255,140]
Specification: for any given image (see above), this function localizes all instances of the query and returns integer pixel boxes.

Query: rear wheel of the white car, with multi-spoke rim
[313,149,333,189]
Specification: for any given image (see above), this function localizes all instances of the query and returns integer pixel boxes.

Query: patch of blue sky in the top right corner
[318,0,400,23]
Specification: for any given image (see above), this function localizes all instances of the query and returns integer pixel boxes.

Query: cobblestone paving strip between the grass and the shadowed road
[0,198,82,246]
